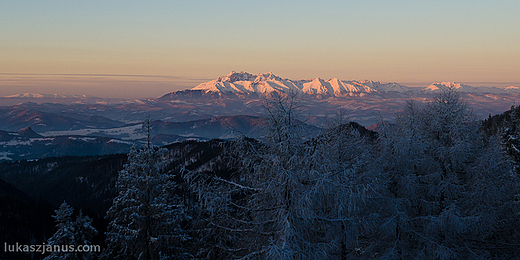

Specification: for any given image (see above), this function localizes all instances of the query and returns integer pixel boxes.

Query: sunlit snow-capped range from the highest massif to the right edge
[191,71,520,97]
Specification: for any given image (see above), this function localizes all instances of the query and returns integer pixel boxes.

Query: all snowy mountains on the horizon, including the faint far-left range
[0,71,520,102]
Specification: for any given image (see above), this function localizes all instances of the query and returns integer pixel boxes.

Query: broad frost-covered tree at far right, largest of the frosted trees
[377,89,519,259]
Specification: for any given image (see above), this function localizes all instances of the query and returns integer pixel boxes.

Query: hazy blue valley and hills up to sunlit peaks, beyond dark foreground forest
[0,72,520,161]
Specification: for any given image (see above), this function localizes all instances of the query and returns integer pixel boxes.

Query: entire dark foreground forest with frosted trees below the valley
[0,91,520,259]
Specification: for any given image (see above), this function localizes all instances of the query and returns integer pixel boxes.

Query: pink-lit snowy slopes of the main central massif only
[192,71,412,97]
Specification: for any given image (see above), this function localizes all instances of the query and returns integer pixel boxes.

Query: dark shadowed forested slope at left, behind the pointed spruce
[0,140,224,259]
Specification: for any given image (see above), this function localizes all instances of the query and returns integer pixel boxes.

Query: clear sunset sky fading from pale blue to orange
[0,0,520,98]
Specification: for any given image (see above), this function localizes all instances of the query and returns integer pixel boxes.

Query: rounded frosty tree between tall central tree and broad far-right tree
[305,116,382,259]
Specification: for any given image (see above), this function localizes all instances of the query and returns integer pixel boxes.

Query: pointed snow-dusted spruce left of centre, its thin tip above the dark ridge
[104,120,189,260]
